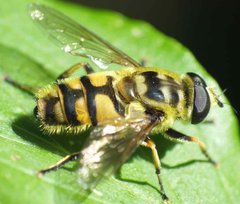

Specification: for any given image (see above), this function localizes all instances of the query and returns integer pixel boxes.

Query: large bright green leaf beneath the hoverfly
[0,0,240,204]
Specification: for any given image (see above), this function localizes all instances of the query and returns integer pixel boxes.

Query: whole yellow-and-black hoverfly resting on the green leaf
[6,4,223,203]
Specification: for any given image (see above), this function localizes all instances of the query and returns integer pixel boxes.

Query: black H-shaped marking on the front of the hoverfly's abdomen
[80,76,124,125]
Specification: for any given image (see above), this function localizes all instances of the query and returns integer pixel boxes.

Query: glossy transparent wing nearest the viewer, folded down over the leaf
[78,117,156,189]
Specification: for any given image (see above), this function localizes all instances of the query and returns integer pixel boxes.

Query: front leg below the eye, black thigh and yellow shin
[165,129,218,167]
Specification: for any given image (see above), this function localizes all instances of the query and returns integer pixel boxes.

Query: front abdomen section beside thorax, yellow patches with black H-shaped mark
[80,74,124,125]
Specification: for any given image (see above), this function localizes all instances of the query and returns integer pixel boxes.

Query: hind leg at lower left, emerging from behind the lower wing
[37,152,80,177]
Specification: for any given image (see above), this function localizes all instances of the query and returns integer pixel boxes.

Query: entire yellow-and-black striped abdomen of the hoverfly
[35,73,124,131]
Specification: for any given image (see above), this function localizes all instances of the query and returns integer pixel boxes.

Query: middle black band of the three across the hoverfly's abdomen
[58,84,83,125]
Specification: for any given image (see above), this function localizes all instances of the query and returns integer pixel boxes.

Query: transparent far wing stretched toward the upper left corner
[29,4,140,69]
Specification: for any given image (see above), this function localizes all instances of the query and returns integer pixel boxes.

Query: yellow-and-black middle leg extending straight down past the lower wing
[141,137,169,204]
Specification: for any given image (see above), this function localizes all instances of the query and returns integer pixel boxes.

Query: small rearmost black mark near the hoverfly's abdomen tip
[45,97,59,125]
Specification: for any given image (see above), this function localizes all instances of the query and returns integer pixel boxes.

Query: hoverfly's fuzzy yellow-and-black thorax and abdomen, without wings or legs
[35,65,195,131]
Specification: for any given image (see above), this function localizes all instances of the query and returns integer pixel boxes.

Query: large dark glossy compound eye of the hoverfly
[187,73,211,124]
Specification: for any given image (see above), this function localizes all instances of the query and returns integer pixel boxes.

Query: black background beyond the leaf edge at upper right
[71,0,240,117]
